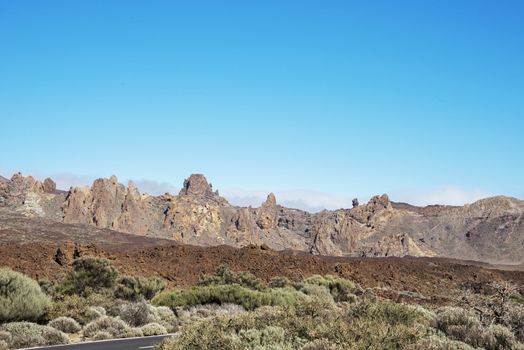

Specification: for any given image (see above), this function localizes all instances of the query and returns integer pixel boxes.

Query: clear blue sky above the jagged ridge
[0,0,524,210]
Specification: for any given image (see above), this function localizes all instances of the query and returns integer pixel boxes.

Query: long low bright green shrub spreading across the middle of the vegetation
[153,285,305,310]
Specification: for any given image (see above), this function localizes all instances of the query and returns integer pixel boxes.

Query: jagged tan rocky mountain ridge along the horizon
[0,173,524,264]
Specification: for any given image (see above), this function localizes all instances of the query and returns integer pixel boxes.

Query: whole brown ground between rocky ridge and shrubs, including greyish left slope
[0,216,524,303]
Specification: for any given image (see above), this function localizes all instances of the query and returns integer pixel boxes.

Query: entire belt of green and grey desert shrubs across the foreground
[0,256,524,350]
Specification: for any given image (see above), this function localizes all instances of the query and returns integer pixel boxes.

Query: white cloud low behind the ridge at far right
[392,185,492,206]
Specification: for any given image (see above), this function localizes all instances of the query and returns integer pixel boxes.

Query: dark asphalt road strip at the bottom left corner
[23,334,172,350]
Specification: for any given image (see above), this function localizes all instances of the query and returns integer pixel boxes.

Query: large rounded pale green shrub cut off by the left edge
[0,268,49,323]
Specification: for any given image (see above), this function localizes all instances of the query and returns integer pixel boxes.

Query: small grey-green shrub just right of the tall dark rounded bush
[115,276,166,301]
